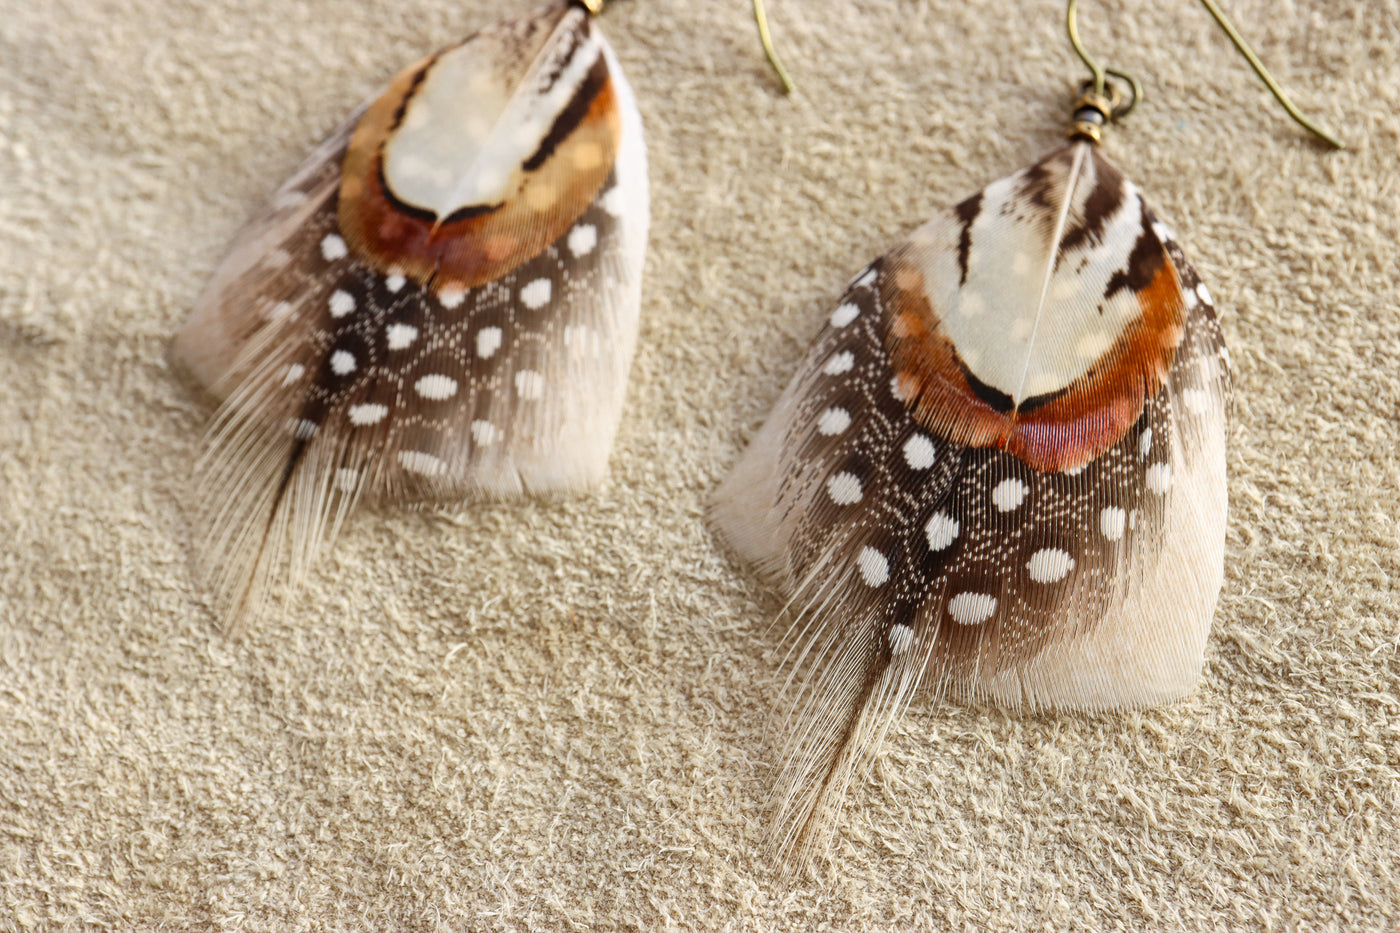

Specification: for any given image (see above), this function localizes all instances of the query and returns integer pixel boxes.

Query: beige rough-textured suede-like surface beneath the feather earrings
[0,0,1400,930]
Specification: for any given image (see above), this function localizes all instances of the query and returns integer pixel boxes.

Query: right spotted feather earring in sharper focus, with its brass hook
[711,0,1340,860]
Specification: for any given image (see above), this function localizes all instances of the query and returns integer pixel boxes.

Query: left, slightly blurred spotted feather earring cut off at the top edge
[172,3,650,628]
